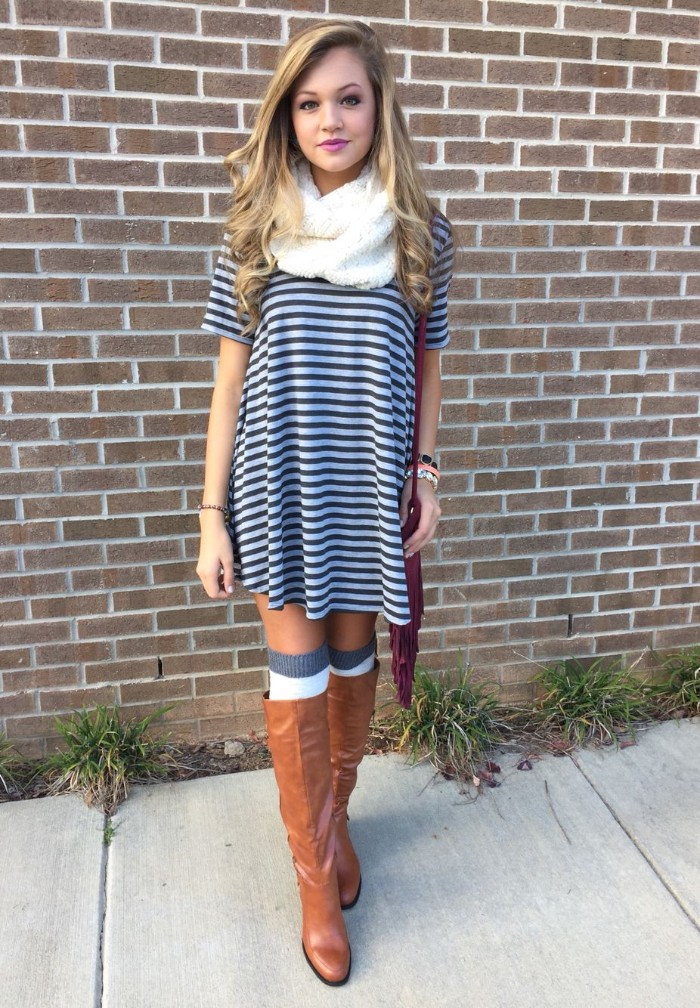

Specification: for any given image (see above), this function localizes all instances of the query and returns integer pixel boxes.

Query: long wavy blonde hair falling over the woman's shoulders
[224,20,434,332]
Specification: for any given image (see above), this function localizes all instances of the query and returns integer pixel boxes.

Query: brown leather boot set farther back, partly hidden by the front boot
[328,661,379,910]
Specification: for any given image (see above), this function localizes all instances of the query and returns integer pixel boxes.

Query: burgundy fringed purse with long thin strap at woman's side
[389,316,428,708]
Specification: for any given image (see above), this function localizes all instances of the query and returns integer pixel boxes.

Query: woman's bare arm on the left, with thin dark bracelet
[197,337,251,599]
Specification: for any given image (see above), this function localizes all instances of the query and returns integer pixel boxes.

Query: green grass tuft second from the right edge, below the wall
[534,657,653,746]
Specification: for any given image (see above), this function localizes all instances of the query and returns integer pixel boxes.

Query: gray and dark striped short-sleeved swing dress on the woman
[202,215,453,624]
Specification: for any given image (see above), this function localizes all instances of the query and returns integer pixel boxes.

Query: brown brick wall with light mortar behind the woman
[0,0,700,753]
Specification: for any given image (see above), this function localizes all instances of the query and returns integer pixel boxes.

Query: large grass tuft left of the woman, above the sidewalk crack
[41,704,179,814]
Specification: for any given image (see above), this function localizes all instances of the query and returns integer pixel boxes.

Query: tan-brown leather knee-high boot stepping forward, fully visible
[262,692,350,987]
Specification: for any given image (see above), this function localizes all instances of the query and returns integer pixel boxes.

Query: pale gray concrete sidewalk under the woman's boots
[0,718,700,1008]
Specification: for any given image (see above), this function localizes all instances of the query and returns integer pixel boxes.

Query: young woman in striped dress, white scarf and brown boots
[197,21,452,985]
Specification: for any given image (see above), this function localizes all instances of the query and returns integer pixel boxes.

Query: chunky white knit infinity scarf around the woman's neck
[270,159,396,290]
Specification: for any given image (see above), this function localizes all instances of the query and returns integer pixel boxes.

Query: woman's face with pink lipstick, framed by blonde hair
[291,48,376,196]
